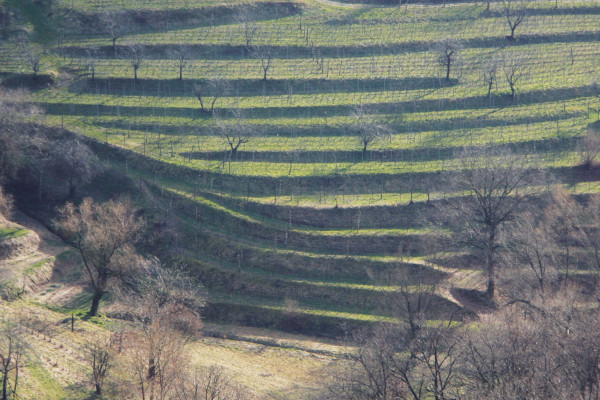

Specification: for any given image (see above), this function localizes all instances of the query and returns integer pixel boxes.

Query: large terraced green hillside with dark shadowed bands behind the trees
[0,0,600,335]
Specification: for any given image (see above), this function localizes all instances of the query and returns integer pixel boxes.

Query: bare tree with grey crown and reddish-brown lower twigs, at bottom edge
[127,260,204,400]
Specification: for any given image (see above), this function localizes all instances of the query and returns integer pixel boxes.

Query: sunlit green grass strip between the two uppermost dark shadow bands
[106,11,598,46]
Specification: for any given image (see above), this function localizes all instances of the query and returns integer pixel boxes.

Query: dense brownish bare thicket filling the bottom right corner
[461,289,600,400]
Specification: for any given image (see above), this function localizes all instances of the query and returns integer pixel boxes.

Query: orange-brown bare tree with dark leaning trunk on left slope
[55,198,143,316]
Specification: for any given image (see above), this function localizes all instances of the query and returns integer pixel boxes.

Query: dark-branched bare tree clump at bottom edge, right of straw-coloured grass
[326,322,460,400]
